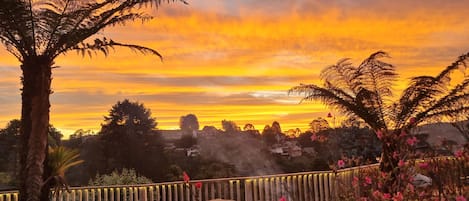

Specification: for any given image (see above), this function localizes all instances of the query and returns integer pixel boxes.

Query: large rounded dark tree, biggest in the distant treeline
[100,99,166,178]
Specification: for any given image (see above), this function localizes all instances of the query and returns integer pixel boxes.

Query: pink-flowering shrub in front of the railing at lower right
[336,141,469,201]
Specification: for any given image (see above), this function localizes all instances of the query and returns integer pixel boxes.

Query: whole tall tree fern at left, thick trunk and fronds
[0,0,186,201]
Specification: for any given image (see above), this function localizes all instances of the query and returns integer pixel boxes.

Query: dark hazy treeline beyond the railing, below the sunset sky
[0,99,380,187]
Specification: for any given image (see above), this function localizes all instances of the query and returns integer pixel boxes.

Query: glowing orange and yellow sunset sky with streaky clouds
[0,0,469,136]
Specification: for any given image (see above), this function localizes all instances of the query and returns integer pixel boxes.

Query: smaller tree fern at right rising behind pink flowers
[289,51,469,190]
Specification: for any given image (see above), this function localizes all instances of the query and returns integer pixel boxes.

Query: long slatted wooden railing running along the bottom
[0,158,459,201]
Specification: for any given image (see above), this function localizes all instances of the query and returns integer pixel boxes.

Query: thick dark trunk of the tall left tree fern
[19,56,53,201]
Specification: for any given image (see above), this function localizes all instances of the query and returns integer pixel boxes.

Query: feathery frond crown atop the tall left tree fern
[0,0,187,60]
